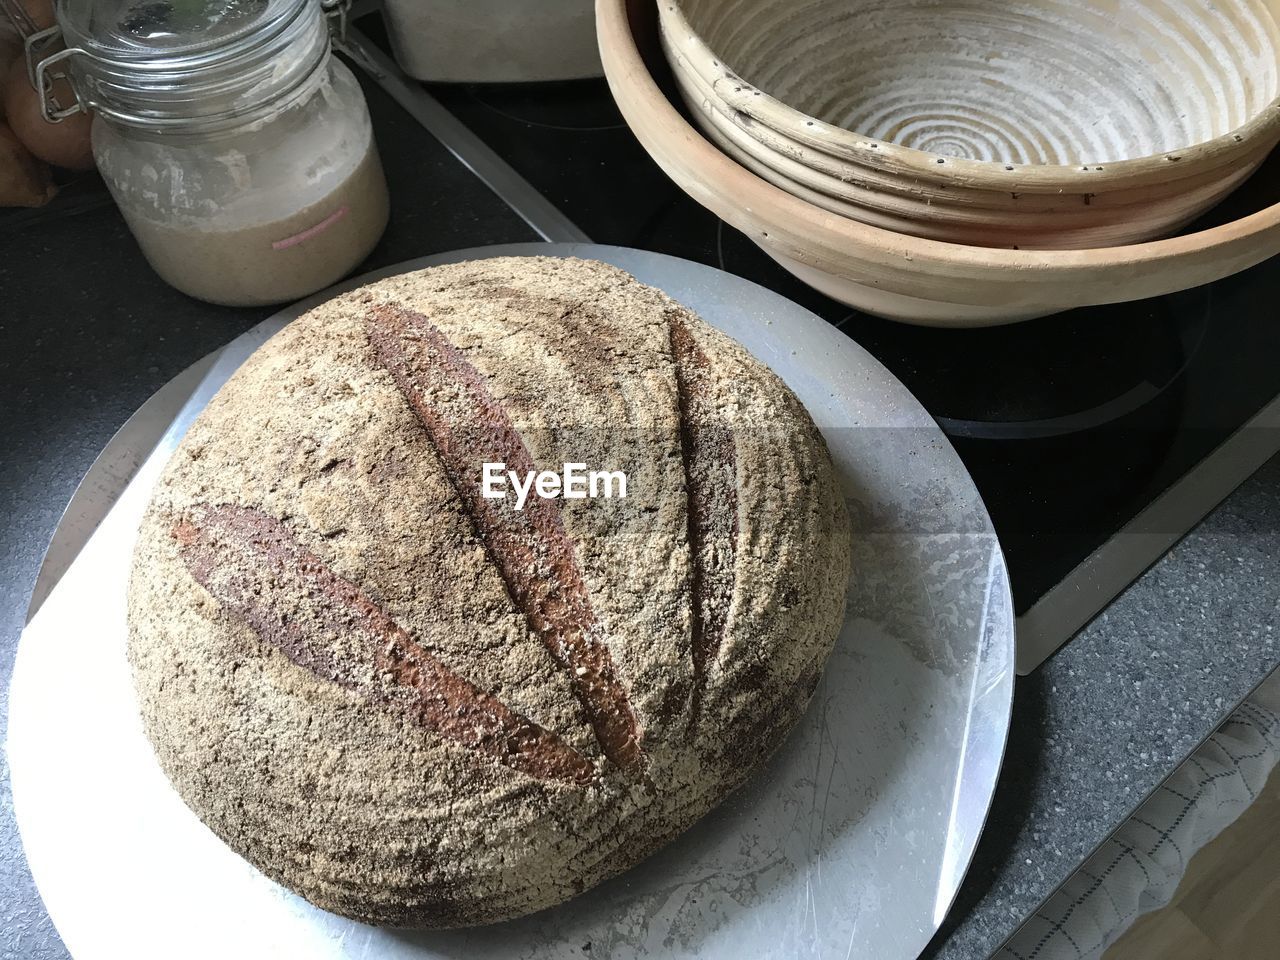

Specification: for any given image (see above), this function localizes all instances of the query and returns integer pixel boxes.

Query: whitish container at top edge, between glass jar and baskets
[384,0,603,83]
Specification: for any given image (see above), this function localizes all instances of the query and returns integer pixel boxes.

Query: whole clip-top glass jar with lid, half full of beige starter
[49,0,388,306]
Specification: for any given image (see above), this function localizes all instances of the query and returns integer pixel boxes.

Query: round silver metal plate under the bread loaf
[8,243,1014,960]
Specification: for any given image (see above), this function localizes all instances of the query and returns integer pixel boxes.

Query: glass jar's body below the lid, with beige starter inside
[93,61,388,306]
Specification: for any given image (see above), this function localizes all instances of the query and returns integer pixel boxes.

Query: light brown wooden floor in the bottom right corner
[1103,769,1280,960]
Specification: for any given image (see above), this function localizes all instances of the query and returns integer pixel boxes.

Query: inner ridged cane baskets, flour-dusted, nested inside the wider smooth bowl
[659,0,1280,250]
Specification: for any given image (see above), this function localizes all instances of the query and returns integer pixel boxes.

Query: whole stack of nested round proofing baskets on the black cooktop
[598,0,1280,325]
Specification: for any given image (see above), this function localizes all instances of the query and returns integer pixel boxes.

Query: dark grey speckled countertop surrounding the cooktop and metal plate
[0,69,1280,960]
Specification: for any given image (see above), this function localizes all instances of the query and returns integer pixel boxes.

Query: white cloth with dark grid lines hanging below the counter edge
[996,675,1280,960]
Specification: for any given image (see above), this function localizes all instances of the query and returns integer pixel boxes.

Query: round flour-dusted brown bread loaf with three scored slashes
[129,257,850,927]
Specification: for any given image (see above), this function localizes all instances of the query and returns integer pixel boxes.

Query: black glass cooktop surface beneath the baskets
[430,81,1280,632]
